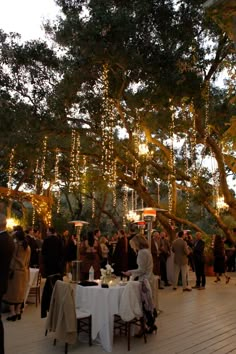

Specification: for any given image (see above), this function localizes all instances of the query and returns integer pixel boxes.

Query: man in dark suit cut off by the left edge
[0,214,15,354]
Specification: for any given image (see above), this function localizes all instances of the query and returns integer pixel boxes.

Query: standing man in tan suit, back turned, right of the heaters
[172,231,192,291]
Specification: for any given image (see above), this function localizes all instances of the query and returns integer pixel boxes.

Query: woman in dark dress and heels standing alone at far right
[213,235,230,284]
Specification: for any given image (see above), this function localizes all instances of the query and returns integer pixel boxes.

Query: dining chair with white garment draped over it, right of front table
[114,281,147,351]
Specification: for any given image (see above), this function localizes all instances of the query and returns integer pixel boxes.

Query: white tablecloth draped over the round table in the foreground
[75,285,124,352]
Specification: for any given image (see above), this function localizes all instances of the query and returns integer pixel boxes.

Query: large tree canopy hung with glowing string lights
[0,0,236,236]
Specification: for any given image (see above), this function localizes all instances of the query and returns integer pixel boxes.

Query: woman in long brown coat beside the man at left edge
[3,228,30,321]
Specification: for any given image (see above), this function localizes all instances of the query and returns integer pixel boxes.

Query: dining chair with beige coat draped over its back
[45,280,92,354]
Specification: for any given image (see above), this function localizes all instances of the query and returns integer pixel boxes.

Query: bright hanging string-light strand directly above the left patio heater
[69,129,80,192]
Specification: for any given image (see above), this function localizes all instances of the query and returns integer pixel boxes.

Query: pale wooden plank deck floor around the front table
[3,273,236,354]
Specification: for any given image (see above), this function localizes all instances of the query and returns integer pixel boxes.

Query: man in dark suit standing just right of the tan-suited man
[193,232,206,290]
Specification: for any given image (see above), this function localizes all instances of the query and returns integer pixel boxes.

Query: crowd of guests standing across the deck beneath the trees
[0,209,236,353]
